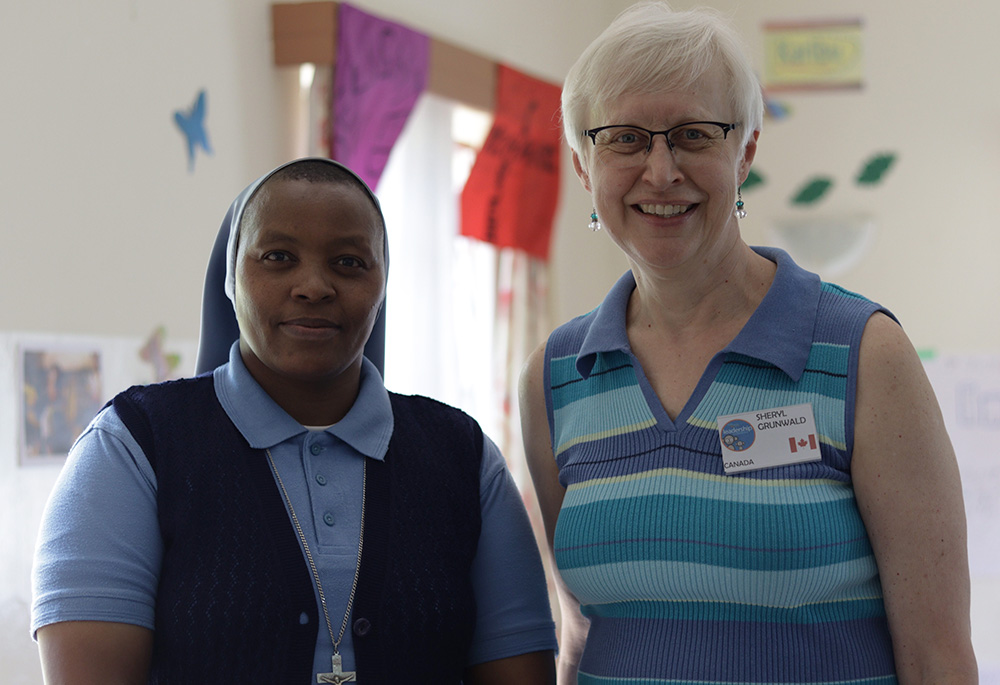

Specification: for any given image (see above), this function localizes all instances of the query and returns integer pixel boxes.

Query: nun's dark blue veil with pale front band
[196,157,389,373]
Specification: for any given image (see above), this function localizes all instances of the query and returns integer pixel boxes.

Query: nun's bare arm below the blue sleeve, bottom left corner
[37,621,153,685]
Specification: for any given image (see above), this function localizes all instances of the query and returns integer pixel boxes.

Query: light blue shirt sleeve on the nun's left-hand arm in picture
[31,407,162,634]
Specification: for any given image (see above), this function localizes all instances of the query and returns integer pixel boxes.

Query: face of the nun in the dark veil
[235,180,385,400]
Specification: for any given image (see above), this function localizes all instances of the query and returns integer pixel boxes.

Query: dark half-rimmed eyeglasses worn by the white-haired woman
[583,121,739,168]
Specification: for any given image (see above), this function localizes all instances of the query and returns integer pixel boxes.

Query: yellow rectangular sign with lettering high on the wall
[764,19,863,90]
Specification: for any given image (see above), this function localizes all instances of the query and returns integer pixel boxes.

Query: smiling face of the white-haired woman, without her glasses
[574,61,756,270]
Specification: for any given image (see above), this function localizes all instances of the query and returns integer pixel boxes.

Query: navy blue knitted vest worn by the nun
[113,375,482,685]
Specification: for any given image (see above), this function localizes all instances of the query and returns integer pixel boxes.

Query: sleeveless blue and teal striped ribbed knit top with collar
[546,249,896,685]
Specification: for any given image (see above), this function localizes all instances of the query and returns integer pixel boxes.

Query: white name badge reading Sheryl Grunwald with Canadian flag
[716,404,820,475]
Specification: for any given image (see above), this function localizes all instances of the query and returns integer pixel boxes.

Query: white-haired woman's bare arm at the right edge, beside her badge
[851,314,978,684]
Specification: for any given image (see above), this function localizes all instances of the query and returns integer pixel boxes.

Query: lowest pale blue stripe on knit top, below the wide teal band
[557,555,882,607]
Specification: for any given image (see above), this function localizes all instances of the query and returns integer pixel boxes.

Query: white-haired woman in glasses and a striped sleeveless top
[521,3,976,685]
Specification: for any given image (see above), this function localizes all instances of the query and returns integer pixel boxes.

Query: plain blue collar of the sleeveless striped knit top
[576,247,822,381]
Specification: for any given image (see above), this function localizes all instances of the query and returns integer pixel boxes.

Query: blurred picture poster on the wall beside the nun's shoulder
[17,343,104,465]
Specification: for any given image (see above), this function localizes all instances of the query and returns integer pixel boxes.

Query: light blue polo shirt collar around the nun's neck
[214,341,393,461]
